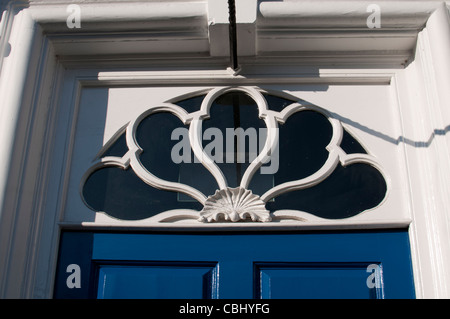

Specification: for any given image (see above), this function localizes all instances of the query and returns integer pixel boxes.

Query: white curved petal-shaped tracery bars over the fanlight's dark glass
[80,87,387,222]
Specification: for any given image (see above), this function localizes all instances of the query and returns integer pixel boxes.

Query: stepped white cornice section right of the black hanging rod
[257,1,441,58]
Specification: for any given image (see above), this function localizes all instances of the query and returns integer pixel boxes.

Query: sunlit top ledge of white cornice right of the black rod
[258,1,439,29]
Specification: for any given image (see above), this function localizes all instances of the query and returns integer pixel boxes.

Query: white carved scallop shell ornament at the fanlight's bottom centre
[199,187,272,222]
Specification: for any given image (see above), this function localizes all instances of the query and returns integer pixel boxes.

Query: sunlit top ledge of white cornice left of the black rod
[30,1,207,32]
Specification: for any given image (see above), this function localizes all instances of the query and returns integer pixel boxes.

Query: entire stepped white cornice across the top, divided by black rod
[8,0,438,65]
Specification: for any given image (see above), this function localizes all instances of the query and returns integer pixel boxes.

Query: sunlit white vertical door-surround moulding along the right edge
[399,3,450,298]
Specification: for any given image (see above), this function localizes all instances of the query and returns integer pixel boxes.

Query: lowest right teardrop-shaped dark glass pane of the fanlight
[267,163,387,219]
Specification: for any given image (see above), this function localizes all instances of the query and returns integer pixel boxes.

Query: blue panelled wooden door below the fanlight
[55,230,415,299]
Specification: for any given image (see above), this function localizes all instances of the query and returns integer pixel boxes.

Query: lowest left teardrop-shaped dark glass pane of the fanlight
[83,167,202,220]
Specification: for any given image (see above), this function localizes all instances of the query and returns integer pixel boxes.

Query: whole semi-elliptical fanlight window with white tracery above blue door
[81,87,387,222]
